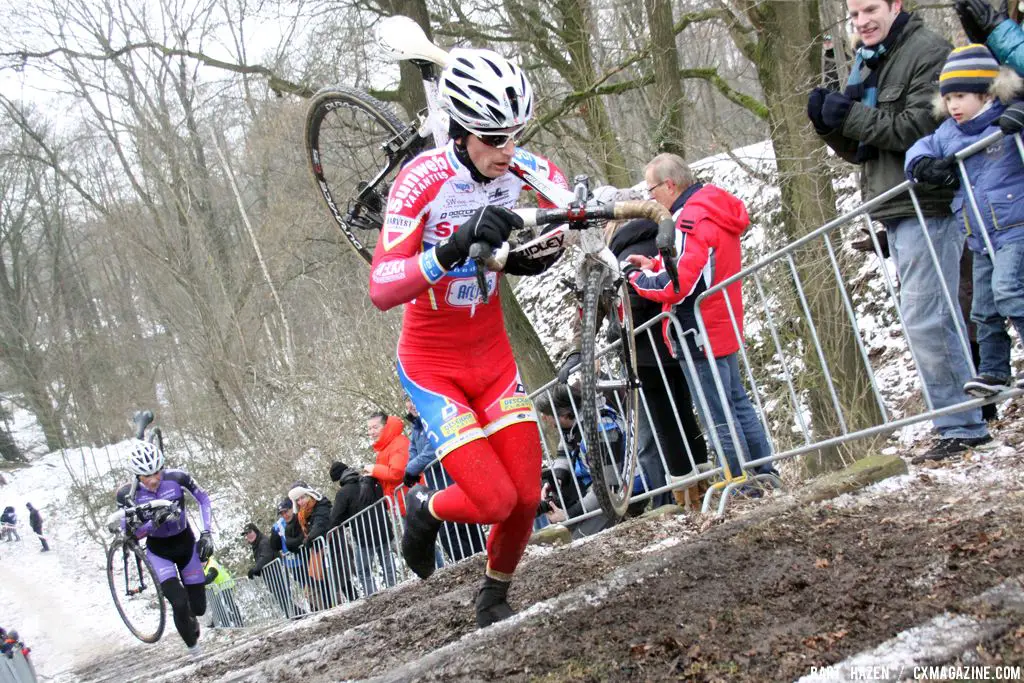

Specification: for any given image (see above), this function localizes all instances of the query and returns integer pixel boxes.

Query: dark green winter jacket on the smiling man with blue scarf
[821,14,952,220]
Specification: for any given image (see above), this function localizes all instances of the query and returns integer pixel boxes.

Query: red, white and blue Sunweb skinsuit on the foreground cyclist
[370,143,566,581]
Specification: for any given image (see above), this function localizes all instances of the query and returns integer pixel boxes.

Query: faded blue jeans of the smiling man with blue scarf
[886,216,988,438]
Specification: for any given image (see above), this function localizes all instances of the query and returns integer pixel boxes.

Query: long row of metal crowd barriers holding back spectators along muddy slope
[218,126,1024,625]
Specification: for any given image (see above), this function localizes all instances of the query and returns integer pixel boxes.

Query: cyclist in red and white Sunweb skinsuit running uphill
[370,49,566,627]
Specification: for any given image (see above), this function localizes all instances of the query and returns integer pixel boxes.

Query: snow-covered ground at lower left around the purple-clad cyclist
[0,409,249,677]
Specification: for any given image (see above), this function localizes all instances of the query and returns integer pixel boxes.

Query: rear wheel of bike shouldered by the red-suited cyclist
[305,87,425,263]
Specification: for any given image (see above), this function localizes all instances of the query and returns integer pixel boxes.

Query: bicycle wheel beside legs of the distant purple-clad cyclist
[106,539,167,643]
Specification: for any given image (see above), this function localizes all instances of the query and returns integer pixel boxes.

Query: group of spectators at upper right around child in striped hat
[807,0,1024,462]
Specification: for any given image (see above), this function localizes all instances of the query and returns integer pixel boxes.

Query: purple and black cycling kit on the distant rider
[117,470,211,585]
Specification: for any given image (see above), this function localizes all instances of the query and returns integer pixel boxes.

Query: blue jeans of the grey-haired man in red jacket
[680,353,773,477]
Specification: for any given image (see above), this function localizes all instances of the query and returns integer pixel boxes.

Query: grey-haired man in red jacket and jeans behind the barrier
[625,154,774,478]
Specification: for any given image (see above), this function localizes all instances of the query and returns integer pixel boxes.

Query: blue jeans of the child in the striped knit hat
[971,242,1024,379]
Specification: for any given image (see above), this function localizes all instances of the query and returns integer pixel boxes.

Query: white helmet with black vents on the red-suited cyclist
[437,48,534,134]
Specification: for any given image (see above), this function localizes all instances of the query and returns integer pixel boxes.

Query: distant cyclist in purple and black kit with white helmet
[117,440,213,654]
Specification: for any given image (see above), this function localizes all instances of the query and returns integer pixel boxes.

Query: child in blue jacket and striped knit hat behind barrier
[904,44,1024,396]
